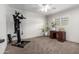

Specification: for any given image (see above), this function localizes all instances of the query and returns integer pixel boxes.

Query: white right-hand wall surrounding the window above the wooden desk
[48,7,79,43]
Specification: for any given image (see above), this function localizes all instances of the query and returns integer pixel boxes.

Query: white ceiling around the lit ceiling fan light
[9,4,78,15]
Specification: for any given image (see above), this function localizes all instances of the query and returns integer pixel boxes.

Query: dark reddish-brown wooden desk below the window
[50,31,66,42]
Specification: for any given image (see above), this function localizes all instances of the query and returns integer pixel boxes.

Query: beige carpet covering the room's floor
[5,37,79,54]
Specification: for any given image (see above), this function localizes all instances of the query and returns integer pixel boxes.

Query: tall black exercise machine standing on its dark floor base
[12,11,30,48]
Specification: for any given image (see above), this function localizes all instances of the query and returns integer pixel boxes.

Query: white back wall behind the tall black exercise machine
[7,7,45,39]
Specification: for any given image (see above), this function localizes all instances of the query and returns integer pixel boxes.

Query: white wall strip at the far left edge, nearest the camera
[0,4,7,53]
